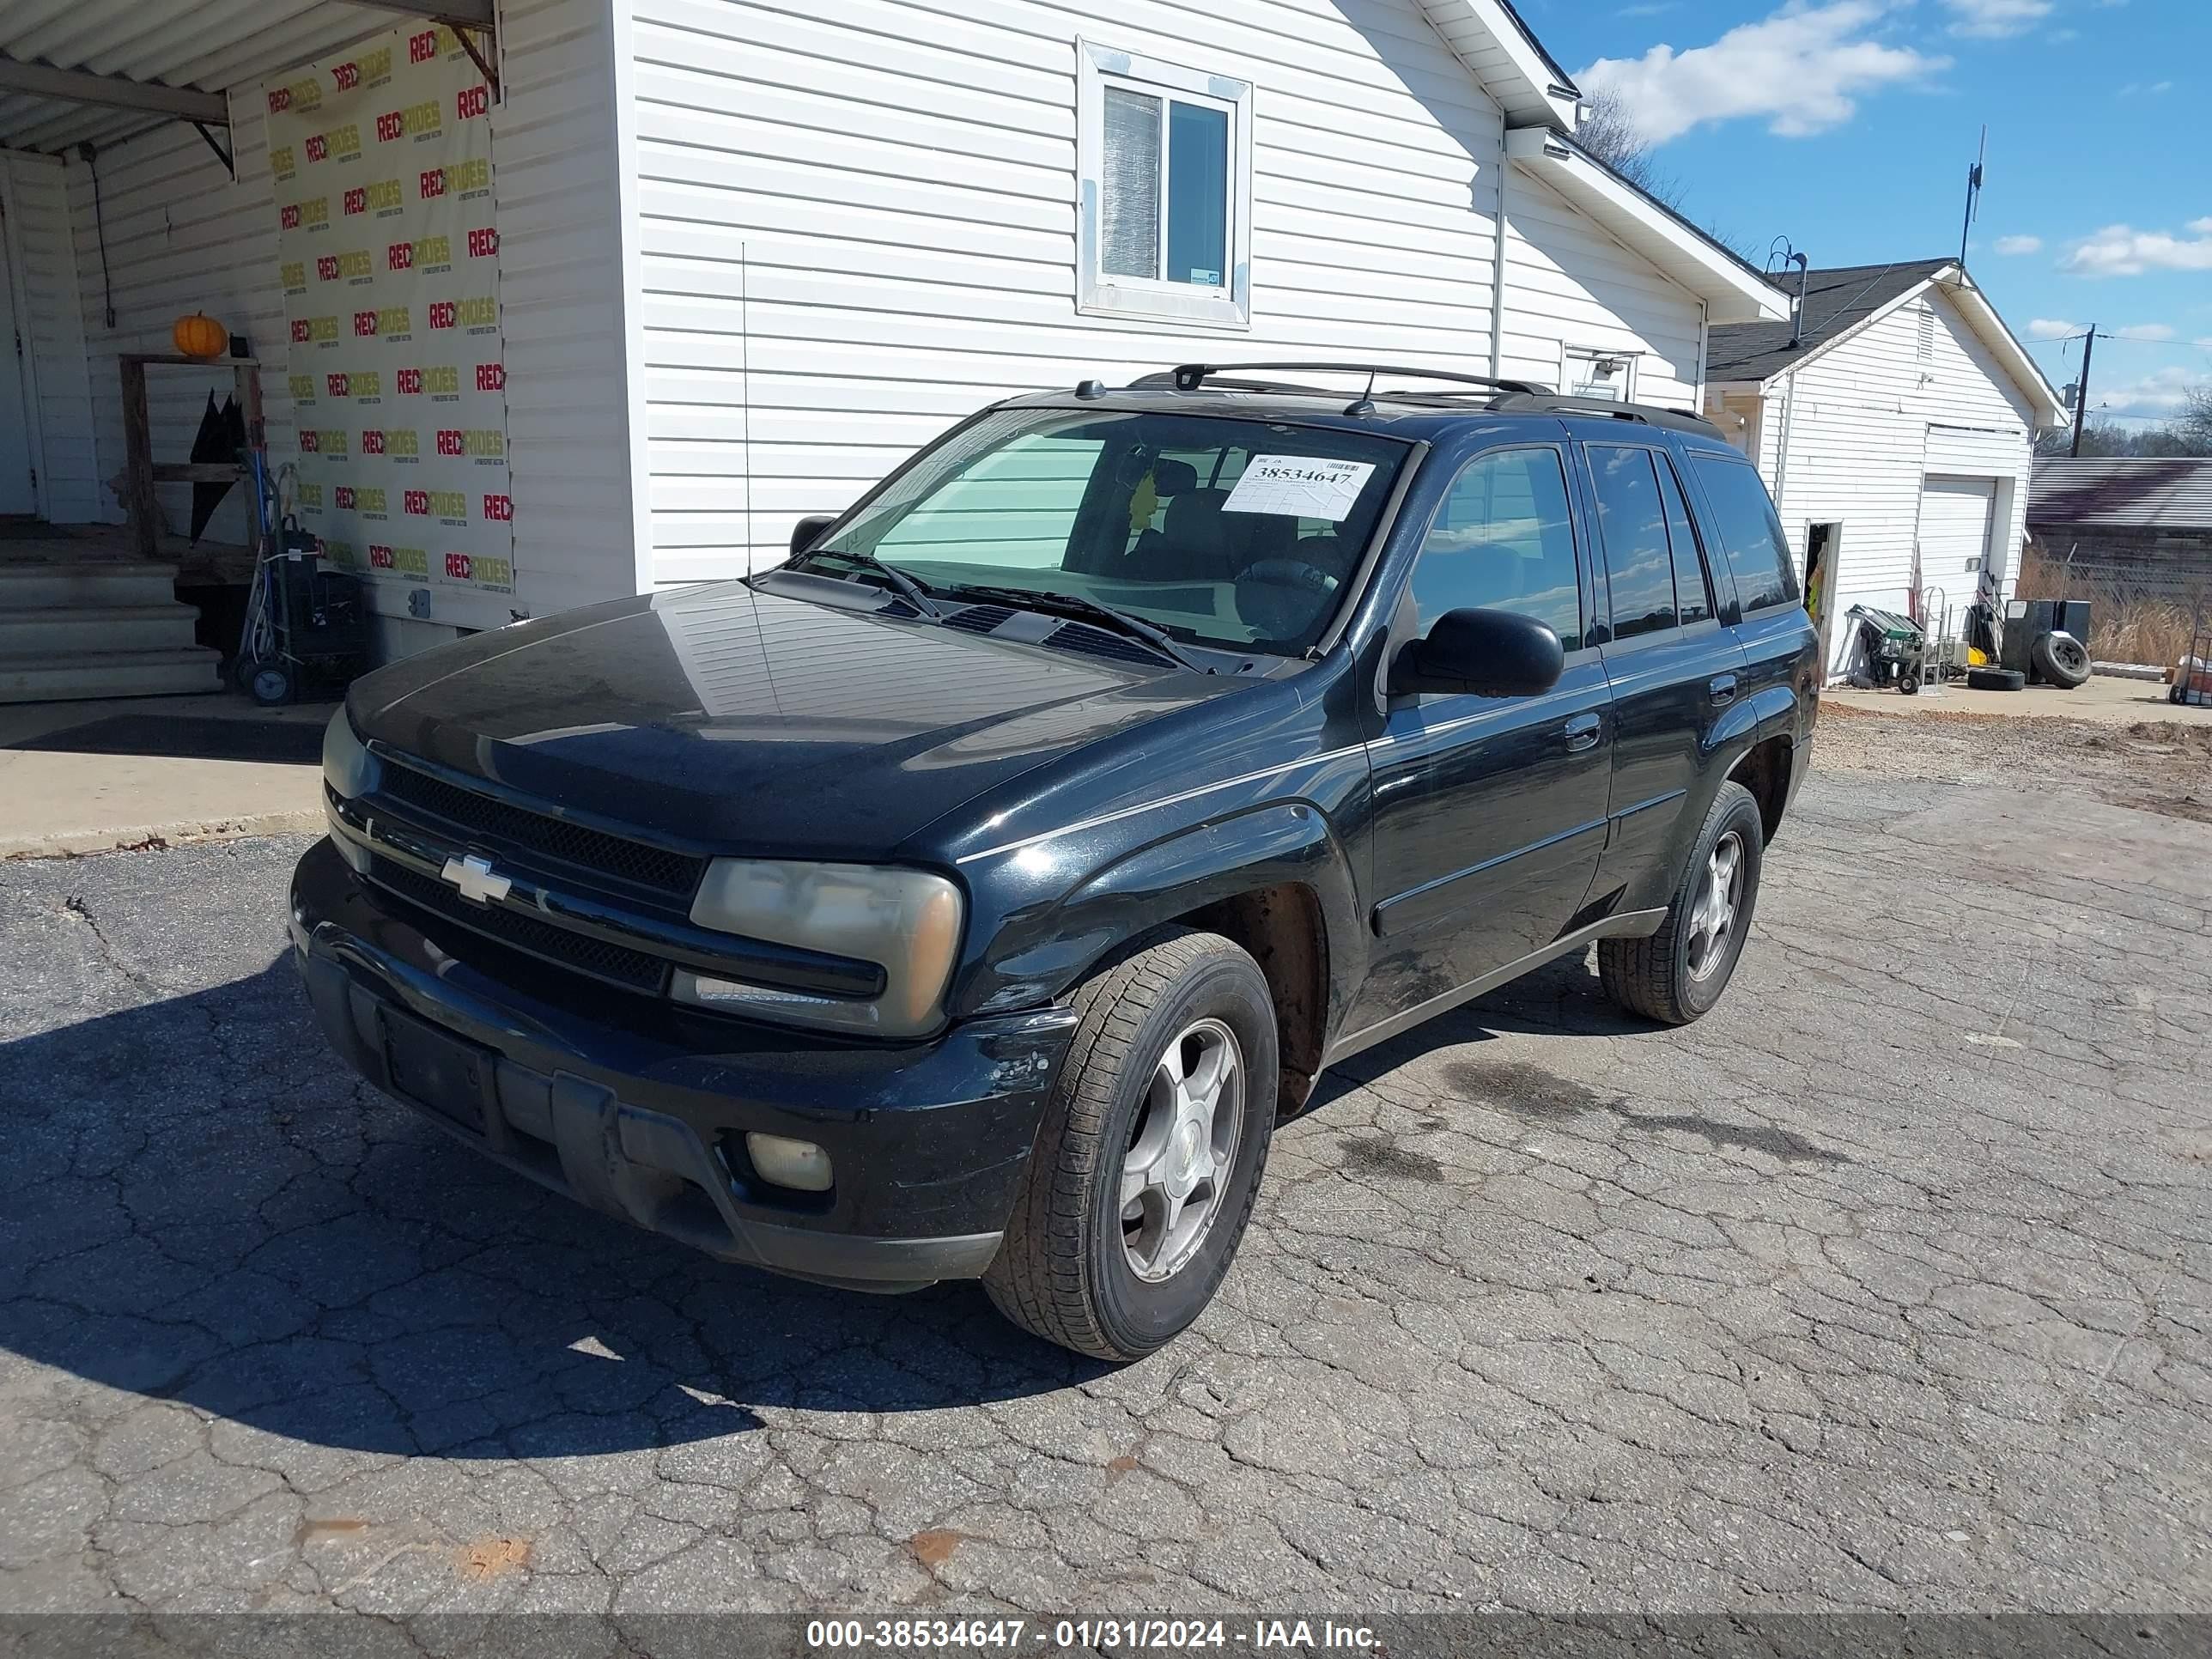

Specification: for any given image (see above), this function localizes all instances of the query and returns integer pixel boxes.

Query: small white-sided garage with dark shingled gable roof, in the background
[1705,258,2066,672]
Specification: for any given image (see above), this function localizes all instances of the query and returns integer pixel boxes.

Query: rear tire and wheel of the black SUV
[1597,783,1765,1026]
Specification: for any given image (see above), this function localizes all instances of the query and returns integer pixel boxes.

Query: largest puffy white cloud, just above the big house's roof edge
[1575,0,1955,143]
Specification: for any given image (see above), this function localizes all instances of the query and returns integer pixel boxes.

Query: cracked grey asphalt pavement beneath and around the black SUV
[0,747,2212,1614]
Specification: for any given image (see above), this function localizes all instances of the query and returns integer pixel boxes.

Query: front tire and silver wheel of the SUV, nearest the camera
[982,929,1276,1360]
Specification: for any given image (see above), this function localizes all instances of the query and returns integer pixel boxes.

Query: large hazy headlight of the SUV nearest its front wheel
[672,858,964,1037]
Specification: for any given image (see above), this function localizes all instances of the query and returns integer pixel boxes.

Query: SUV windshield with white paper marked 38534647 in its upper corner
[807,410,1407,654]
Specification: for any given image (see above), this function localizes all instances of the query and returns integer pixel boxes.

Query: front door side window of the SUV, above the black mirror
[1413,449,1582,650]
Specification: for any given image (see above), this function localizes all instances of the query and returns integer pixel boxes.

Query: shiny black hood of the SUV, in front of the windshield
[347,581,1252,858]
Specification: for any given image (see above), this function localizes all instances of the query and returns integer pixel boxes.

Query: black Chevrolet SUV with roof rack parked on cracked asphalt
[292,365,1818,1360]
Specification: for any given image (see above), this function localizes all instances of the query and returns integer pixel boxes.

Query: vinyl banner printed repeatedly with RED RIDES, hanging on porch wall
[265,24,515,592]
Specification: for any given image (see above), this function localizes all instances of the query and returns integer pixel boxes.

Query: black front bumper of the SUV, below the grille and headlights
[292,841,1075,1290]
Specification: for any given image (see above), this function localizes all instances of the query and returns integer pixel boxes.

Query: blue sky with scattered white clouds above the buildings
[1517,0,2212,418]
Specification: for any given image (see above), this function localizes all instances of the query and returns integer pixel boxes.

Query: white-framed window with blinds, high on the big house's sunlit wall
[1075,40,1252,330]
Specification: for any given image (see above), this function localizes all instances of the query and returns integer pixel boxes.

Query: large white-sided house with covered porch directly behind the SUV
[0,0,1785,685]
